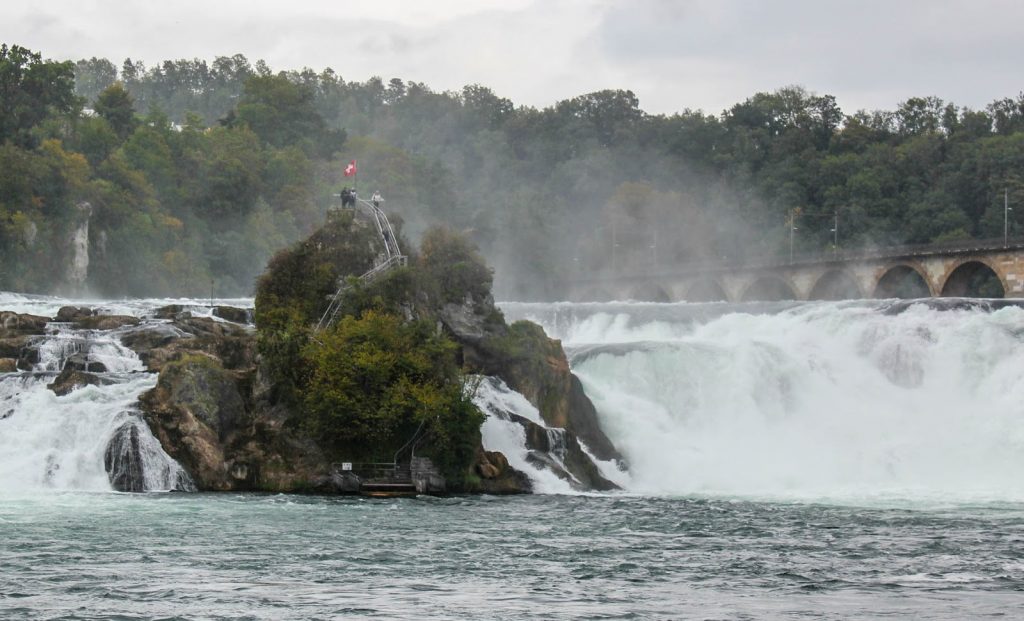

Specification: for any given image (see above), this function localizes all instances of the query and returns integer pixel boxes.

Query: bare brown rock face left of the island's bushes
[130,309,338,492]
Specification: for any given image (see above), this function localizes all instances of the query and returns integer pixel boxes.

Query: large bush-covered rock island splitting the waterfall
[132,211,618,493]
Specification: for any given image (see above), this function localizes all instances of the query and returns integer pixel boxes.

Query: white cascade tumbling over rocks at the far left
[0,323,195,492]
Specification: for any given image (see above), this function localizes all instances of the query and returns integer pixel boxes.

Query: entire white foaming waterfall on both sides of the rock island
[0,294,1024,500]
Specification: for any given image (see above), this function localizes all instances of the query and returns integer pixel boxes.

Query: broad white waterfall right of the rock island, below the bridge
[504,302,1024,500]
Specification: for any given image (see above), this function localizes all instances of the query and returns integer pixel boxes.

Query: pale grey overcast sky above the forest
[0,0,1024,114]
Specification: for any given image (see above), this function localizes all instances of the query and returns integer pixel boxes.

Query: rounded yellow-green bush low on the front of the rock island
[302,311,483,470]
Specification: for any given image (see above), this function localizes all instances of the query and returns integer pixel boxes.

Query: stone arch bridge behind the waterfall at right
[564,239,1024,302]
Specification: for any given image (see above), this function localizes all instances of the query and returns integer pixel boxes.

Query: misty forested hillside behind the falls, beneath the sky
[0,46,1024,298]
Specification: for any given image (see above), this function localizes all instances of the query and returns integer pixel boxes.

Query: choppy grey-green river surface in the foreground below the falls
[0,493,1024,619]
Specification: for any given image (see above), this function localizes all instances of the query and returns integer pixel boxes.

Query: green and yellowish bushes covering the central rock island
[256,221,489,483]
